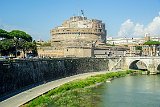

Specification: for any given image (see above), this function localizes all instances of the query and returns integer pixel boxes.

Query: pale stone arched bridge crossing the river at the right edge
[124,56,160,74]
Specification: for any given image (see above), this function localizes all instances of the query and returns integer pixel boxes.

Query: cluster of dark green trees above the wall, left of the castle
[0,29,37,57]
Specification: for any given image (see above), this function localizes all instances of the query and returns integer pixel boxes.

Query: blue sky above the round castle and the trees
[0,0,160,40]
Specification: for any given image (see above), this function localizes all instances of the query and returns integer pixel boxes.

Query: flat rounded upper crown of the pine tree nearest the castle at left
[9,30,32,42]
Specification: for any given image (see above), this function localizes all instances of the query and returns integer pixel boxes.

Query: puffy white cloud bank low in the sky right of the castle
[118,16,160,37]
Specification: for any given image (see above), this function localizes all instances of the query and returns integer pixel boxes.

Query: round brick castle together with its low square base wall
[38,14,106,57]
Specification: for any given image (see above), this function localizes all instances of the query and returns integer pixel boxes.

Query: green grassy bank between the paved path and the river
[22,70,139,107]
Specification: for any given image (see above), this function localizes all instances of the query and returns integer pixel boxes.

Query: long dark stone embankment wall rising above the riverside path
[0,58,109,97]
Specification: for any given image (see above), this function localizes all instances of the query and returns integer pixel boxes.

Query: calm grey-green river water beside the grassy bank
[96,75,160,107]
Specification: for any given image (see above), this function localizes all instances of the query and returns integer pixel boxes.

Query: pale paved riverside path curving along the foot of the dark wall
[0,71,120,107]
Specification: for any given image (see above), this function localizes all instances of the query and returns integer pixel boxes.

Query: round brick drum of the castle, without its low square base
[51,15,106,47]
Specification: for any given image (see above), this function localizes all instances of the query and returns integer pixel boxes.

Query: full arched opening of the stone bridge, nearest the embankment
[129,60,148,71]
